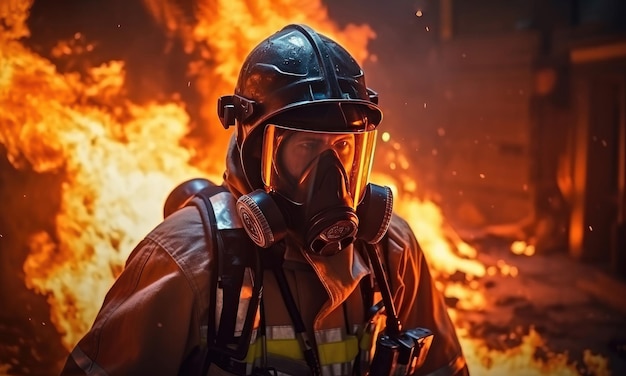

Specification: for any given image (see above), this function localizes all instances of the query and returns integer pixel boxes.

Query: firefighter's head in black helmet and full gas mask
[218,25,391,254]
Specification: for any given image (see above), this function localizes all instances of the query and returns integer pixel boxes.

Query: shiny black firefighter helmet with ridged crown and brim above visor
[218,25,382,189]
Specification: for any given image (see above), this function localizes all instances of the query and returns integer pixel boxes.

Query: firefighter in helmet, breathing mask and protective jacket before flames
[62,25,468,375]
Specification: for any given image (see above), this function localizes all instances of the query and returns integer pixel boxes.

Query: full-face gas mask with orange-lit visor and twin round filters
[237,124,393,255]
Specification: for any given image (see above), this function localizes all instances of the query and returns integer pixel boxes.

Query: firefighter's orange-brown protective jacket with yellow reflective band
[62,140,467,375]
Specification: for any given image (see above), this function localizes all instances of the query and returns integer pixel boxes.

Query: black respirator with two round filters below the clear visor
[237,126,393,255]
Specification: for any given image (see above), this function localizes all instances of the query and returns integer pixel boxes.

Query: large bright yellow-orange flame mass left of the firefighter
[0,0,206,348]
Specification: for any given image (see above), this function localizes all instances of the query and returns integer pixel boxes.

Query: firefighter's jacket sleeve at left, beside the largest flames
[61,239,197,375]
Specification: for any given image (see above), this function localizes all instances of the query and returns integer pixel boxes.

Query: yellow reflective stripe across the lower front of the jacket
[245,336,359,365]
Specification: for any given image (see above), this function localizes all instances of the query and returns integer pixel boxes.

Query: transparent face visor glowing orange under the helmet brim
[261,124,376,209]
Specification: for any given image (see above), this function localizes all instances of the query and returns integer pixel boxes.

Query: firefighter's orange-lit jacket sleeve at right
[386,216,468,375]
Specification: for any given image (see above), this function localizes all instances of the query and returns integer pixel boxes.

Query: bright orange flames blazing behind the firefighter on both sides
[0,0,602,374]
